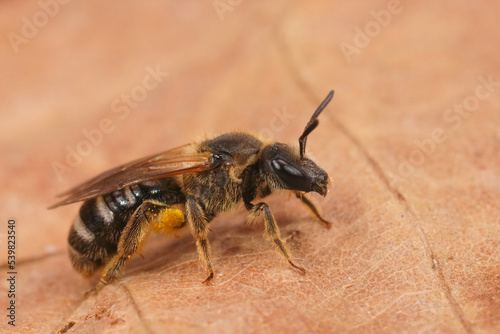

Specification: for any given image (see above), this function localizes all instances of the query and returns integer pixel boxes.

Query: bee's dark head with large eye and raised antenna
[260,91,333,196]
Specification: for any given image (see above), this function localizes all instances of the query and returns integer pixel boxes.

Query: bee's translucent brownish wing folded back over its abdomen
[49,144,212,209]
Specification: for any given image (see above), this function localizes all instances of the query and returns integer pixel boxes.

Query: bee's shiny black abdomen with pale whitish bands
[68,178,184,276]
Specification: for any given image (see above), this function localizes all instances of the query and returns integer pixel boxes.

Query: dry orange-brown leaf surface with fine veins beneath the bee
[0,0,500,333]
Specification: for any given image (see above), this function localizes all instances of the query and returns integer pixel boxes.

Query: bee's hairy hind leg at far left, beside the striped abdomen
[92,200,169,294]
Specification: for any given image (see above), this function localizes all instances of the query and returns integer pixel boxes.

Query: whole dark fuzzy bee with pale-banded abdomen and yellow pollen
[49,91,333,291]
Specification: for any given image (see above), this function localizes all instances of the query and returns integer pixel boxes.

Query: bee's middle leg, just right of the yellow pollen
[186,196,214,285]
